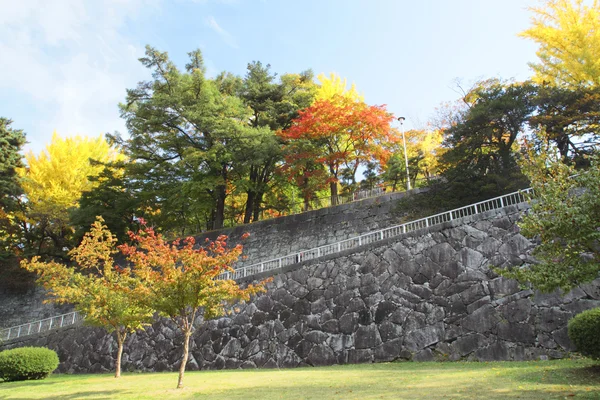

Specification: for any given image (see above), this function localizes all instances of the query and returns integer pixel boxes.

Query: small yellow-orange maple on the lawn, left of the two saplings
[21,217,152,378]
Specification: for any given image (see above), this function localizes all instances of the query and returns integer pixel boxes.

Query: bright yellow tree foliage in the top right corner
[520,0,600,87]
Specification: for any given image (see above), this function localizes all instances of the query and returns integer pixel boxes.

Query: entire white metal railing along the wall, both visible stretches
[0,188,531,340]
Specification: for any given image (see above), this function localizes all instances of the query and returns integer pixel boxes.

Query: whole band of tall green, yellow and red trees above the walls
[8,5,600,300]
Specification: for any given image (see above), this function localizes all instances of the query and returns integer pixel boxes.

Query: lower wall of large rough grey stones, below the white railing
[4,208,600,372]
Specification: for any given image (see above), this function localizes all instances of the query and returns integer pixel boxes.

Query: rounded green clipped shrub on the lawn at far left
[0,347,58,381]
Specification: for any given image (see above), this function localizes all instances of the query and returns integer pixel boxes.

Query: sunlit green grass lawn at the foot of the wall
[0,360,600,400]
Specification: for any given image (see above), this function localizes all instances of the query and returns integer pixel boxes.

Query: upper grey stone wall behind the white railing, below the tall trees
[0,189,426,328]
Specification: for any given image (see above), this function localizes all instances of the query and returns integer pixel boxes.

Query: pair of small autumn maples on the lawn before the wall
[21,217,265,387]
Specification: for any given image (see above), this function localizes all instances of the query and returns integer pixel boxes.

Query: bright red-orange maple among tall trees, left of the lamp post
[278,94,397,203]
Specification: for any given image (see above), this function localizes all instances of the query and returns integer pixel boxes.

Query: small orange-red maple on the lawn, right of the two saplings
[119,220,265,388]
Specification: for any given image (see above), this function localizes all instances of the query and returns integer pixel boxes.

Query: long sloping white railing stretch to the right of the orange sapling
[219,188,531,279]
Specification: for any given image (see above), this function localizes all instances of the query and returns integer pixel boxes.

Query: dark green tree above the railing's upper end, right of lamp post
[441,79,535,203]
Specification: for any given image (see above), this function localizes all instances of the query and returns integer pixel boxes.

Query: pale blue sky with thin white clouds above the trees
[0,0,537,152]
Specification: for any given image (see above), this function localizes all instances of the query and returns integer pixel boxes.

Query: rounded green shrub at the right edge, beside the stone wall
[569,308,600,360]
